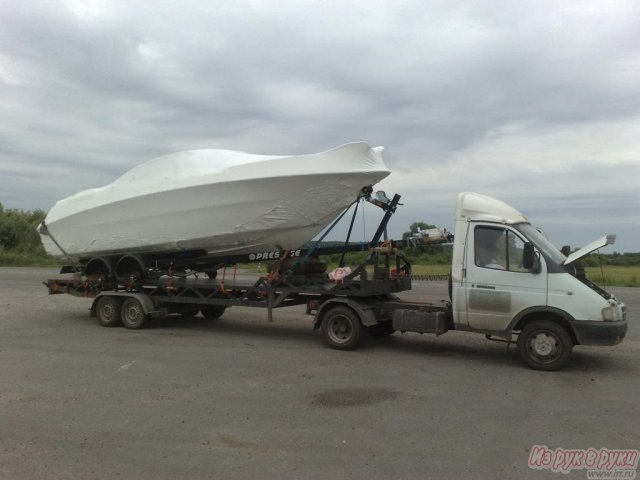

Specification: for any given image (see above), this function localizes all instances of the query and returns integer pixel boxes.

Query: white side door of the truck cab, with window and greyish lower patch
[463,224,547,331]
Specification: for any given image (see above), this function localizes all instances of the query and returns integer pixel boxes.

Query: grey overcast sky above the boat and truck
[0,0,640,252]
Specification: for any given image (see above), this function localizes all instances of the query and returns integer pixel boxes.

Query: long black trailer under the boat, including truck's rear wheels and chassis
[44,195,450,349]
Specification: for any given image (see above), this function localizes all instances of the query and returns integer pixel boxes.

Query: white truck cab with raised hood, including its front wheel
[451,192,627,370]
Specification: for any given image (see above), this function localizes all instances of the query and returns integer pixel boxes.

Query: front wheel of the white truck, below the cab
[518,320,573,371]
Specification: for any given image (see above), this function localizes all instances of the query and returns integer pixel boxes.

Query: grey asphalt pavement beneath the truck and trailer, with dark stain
[0,268,640,480]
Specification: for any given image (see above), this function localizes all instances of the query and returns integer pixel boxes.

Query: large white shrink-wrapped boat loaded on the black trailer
[38,142,390,259]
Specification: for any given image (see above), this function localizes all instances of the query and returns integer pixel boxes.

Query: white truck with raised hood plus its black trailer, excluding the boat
[45,192,627,370]
